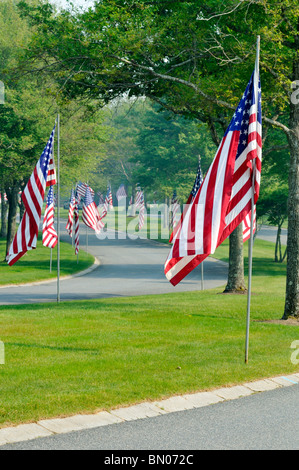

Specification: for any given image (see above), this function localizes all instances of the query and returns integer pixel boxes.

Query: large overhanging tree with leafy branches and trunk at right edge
[16,0,299,318]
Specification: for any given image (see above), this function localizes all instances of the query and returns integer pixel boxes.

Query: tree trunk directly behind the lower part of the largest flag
[224,224,247,292]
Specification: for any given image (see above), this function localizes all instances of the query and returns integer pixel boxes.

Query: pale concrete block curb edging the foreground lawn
[0,373,299,446]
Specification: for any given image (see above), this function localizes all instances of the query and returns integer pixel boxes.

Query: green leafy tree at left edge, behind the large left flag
[0,1,110,253]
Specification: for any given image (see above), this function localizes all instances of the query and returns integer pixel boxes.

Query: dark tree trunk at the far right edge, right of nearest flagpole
[283,54,299,320]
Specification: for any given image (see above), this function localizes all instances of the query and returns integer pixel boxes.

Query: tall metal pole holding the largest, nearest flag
[245,36,260,364]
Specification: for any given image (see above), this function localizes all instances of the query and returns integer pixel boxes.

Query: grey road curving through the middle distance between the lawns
[0,223,227,305]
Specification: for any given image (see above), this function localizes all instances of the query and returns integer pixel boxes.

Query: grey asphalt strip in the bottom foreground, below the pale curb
[0,385,299,452]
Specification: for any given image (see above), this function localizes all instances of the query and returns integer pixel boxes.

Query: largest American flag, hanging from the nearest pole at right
[164,63,262,285]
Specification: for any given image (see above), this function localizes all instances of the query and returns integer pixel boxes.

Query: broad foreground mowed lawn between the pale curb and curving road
[0,240,299,427]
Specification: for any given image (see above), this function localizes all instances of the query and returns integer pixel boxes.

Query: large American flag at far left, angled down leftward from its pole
[7,126,53,266]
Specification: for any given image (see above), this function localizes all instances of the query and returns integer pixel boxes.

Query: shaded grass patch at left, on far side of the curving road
[0,235,94,285]
